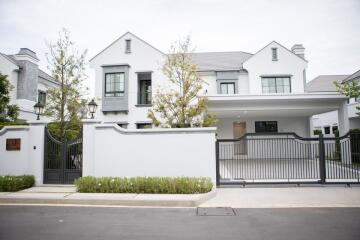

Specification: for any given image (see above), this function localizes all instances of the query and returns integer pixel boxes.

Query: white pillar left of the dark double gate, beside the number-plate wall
[28,120,48,186]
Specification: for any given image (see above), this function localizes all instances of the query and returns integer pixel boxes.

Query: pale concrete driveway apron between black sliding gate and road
[200,185,360,208]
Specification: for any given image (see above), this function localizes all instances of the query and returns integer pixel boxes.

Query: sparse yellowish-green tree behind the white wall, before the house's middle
[148,37,216,128]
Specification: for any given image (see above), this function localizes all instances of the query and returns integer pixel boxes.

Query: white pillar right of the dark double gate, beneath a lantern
[82,119,101,176]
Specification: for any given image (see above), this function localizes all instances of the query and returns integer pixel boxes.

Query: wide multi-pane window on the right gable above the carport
[261,77,291,93]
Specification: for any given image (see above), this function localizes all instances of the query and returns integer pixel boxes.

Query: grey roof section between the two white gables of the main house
[191,51,252,71]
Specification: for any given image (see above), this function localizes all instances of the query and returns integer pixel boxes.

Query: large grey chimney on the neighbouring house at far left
[14,48,39,102]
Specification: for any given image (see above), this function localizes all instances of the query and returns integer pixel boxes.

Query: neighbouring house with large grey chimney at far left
[0,48,59,121]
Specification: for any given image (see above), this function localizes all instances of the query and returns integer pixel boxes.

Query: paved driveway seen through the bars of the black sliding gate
[219,157,360,182]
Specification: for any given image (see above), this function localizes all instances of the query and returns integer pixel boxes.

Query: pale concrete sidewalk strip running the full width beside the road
[0,185,360,208]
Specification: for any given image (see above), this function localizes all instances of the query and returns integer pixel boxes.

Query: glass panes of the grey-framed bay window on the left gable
[105,73,125,97]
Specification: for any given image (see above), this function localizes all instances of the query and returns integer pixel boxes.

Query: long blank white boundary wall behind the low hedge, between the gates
[83,120,216,183]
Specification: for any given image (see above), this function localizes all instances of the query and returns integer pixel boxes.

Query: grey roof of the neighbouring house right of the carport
[305,75,349,92]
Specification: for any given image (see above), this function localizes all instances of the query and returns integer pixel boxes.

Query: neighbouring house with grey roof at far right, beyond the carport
[305,70,360,136]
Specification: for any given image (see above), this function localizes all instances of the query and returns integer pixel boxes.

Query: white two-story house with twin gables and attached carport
[90,32,349,138]
